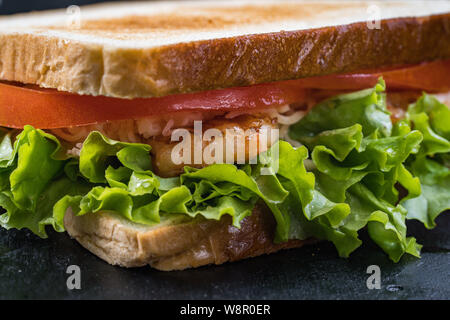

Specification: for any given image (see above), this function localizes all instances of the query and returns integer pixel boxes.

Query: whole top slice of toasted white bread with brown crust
[0,1,450,98]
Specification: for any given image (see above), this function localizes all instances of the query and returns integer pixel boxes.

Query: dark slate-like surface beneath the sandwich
[0,214,450,299]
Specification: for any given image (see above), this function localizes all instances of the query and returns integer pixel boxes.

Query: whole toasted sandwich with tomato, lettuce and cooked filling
[0,1,450,270]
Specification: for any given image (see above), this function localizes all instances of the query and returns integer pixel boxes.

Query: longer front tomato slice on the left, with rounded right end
[0,82,306,129]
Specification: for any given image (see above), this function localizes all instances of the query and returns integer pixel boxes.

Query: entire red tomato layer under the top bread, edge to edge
[0,60,450,129]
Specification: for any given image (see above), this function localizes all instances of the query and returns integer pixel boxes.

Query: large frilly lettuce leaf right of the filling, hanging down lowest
[289,82,423,261]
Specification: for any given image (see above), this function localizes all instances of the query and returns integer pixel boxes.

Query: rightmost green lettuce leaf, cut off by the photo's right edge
[404,94,450,229]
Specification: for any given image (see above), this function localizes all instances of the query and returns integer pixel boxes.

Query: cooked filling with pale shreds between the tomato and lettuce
[52,91,450,177]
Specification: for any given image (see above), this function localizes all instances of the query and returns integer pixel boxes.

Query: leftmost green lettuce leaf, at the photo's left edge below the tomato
[0,126,90,237]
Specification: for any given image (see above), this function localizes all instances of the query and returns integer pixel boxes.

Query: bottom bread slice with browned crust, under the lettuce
[64,206,314,271]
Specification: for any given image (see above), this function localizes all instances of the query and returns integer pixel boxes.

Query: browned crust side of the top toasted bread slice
[0,13,450,98]
